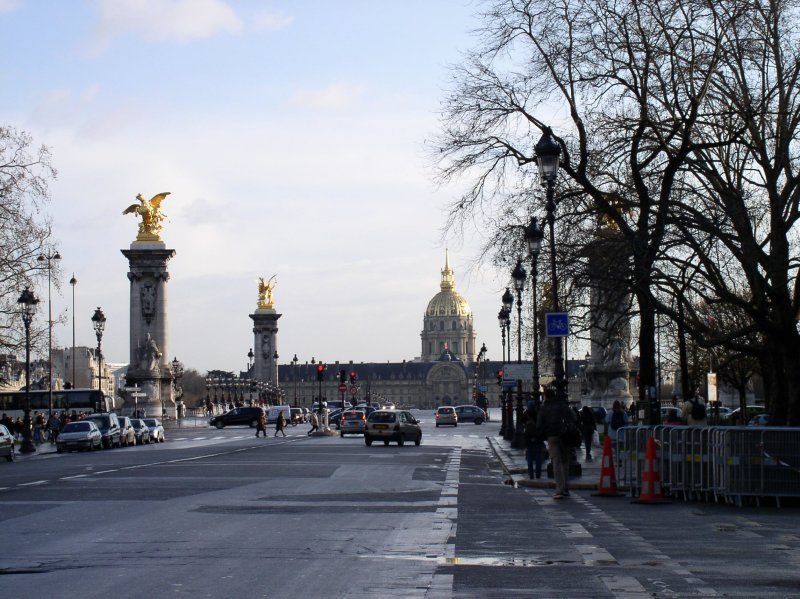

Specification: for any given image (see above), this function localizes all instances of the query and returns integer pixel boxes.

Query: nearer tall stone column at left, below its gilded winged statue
[121,241,176,418]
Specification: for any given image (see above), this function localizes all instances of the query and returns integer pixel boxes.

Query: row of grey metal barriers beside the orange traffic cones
[614,425,800,506]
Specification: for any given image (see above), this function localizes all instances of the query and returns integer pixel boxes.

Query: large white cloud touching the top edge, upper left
[88,0,243,51]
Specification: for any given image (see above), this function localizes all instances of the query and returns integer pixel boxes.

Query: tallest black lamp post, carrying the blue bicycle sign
[534,128,567,401]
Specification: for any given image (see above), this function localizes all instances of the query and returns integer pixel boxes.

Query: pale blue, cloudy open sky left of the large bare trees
[0,0,520,373]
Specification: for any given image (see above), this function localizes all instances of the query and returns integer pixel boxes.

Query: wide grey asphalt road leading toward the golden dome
[0,414,800,599]
